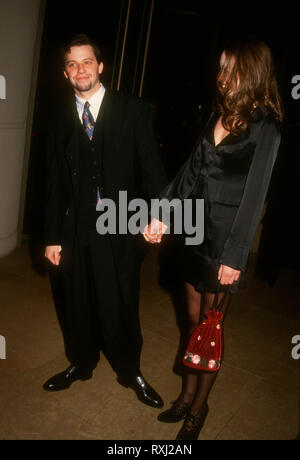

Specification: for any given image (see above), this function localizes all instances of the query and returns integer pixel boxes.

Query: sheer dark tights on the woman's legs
[180,283,231,414]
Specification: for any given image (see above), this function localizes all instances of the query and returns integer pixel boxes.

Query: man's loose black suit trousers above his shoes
[50,227,142,377]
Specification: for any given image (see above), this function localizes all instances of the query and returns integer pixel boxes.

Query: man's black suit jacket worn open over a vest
[44,90,167,272]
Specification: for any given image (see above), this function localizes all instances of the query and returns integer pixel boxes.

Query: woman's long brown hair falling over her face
[214,41,283,135]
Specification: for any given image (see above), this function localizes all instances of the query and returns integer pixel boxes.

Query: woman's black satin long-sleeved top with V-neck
[161,108,281,271]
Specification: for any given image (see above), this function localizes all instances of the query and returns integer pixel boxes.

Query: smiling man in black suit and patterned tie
[44,35,166,407]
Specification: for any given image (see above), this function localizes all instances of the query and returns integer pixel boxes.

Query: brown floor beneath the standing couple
[0,239,300,440]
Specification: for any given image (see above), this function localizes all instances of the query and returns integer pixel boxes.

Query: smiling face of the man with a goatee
[64,45,103,93]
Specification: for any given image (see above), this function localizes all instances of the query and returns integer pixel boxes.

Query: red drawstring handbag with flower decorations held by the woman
[183,293,226,371]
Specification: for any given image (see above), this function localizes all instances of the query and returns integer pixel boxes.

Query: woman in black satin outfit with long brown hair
[144,41,282,440]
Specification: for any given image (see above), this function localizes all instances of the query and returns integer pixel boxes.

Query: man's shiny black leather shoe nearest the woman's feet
[118,375,164,408]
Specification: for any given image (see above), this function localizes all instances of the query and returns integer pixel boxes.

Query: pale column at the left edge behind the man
[0,0,40,257]
